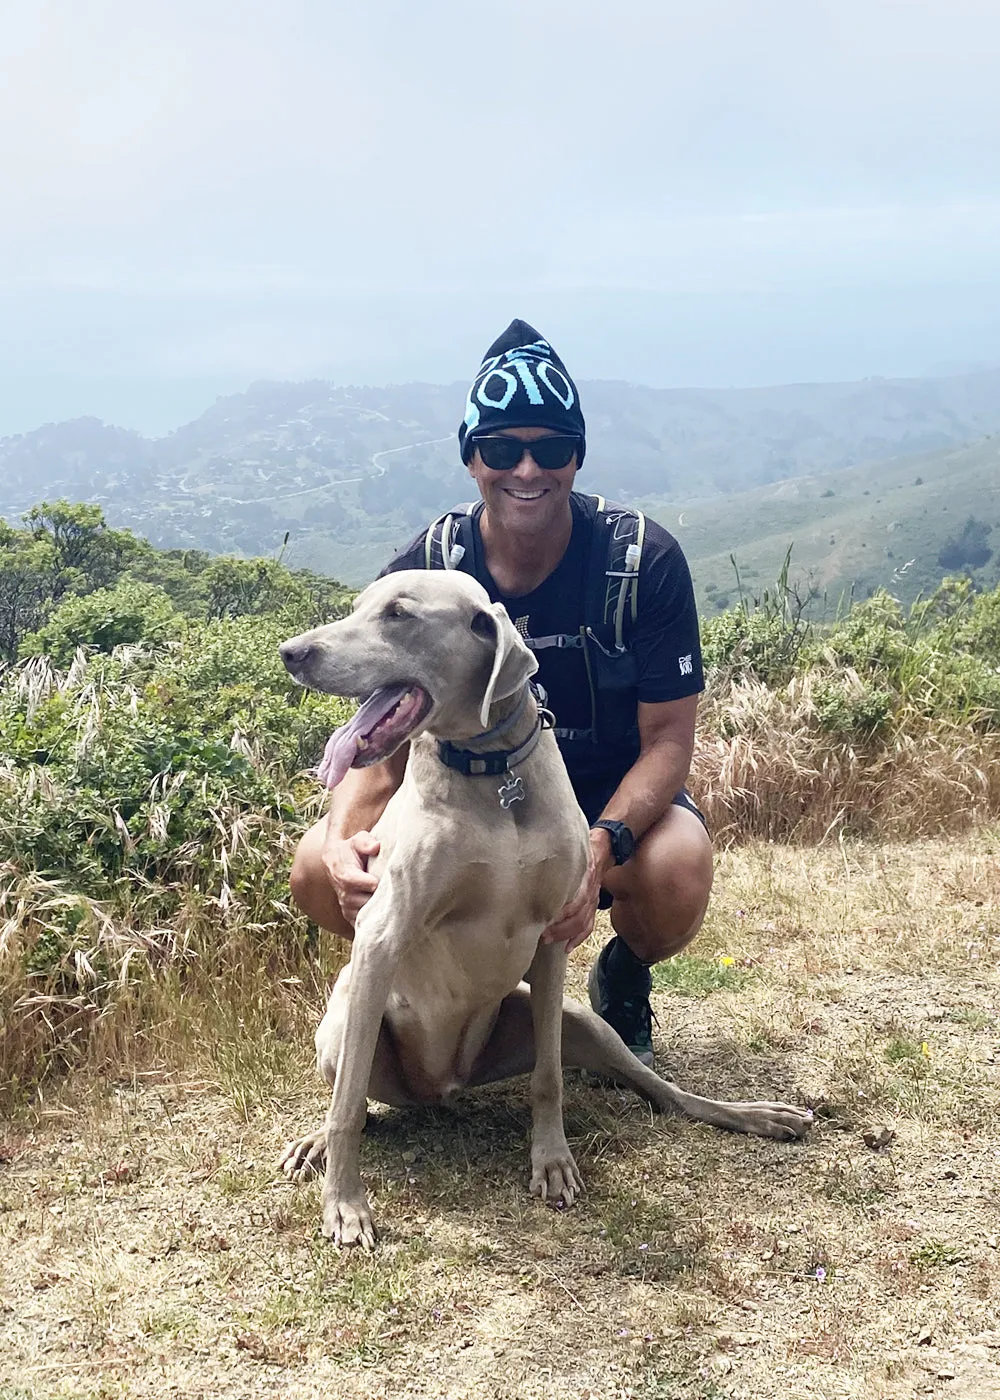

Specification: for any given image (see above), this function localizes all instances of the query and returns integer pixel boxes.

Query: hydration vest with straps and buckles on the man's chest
[424,496,646,755]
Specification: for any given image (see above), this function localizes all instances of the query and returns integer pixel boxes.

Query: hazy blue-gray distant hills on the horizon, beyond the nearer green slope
[0,371,1000,589]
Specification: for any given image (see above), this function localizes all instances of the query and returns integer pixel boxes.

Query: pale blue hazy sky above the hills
[0,0,1000,434]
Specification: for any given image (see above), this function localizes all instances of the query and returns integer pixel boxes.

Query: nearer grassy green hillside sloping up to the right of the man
[641,437,1000,612]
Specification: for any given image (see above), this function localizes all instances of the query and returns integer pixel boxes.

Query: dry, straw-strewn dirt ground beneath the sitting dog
[0,833,1000,1400]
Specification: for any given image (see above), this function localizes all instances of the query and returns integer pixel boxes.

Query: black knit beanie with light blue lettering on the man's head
[458,321,587,465]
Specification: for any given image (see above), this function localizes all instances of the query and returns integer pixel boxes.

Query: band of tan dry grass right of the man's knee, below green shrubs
[692,673,1000,841]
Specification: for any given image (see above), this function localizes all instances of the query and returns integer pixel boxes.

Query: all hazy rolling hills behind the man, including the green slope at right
[0,371,1000,601]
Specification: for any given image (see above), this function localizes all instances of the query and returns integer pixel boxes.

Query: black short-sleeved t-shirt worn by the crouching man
[380,491,704,778]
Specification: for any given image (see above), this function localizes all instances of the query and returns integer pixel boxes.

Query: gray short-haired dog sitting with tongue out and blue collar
[280,570,811,1249]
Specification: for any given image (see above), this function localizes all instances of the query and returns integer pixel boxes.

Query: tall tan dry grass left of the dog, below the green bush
[0,778,330,1103]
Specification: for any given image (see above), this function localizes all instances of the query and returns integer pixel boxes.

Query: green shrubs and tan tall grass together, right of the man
[692,574,1000,841]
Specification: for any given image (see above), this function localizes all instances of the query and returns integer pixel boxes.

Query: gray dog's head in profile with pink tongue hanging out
[279,570,538,767]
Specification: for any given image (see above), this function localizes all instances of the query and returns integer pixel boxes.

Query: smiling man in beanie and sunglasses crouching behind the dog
[291,321,711,1064]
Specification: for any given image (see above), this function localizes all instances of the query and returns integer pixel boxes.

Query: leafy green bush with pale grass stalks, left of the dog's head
[0,615,347,896]
